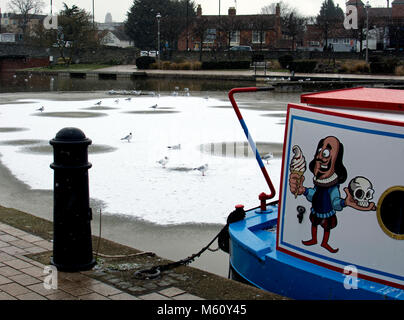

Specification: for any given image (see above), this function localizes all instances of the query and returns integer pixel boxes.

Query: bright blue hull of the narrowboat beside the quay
[229,206,404,300]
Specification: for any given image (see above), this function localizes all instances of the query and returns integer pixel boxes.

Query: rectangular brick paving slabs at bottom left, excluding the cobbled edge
[0,223,201,300]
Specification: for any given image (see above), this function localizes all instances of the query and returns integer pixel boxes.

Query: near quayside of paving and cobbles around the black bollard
[0,202,286,300]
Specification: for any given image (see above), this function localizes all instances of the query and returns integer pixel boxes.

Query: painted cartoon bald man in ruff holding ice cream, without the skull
[289,136,376,253]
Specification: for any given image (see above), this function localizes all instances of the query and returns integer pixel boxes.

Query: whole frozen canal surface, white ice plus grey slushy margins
[0,87,299,276]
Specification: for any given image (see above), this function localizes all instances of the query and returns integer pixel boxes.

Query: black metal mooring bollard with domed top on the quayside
[49,128,96,272]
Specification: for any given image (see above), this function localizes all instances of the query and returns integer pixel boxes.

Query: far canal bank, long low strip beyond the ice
[16,65,404,92]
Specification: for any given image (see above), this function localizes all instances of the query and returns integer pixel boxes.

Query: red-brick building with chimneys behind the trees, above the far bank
[178,4,284,51]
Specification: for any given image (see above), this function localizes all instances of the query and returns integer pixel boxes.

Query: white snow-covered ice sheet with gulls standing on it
[0,94,284,224]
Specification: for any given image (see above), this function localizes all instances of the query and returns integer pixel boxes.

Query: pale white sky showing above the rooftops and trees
[0,0,393,22]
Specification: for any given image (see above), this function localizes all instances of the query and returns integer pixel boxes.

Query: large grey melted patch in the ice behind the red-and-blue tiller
[199,141,283,158]
